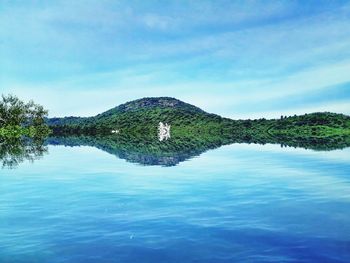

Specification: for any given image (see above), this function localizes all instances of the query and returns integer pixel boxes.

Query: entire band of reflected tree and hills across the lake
[0,132,350,168]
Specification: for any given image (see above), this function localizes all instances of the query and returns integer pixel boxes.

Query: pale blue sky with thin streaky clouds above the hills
[0,0,350,119]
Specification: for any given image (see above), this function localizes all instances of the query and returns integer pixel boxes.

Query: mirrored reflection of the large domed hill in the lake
[47,136,226,166]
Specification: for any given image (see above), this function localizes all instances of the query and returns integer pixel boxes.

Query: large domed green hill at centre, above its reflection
[47,97,224,134]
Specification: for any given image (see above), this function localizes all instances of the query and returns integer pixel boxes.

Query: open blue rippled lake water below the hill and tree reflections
[0,144,350,262]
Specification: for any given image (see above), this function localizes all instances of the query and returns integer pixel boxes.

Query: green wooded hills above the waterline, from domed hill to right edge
[48,98,350,142]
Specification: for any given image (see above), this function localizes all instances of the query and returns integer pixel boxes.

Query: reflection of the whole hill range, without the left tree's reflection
[47,134,350,166]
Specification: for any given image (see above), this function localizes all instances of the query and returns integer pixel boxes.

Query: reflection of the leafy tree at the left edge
[0,137,47,168]
